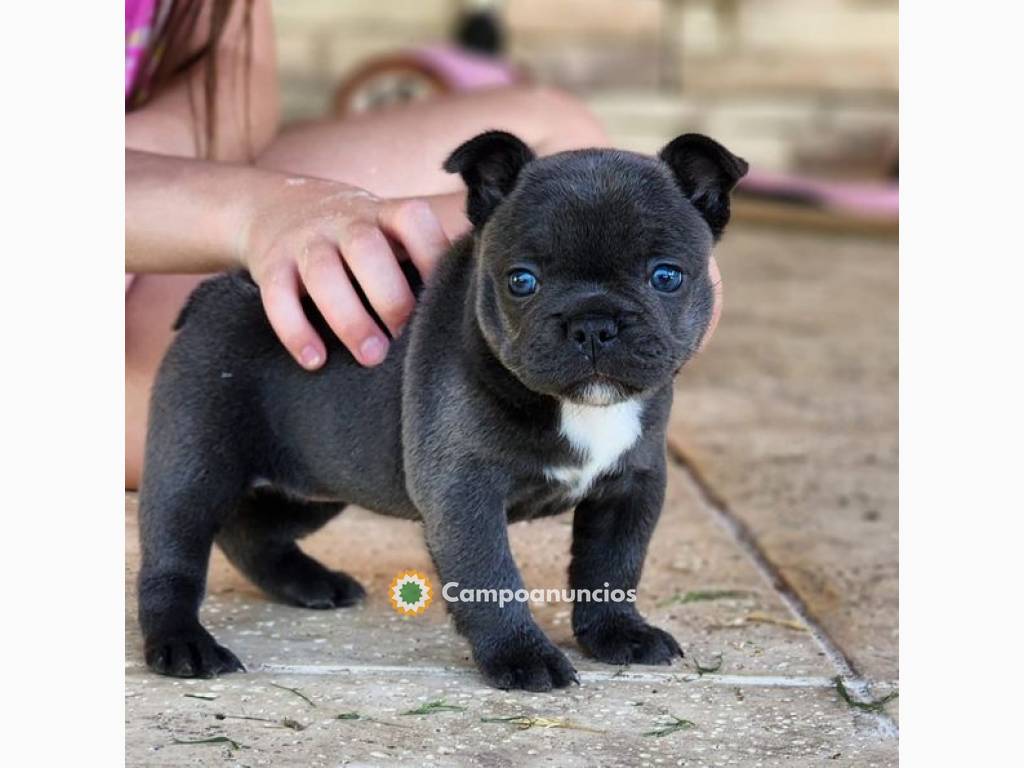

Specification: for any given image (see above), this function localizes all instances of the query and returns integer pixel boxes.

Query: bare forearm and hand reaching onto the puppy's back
[125,150,449,369]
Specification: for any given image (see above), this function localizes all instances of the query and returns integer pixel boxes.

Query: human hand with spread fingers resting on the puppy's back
[238,177,450,371]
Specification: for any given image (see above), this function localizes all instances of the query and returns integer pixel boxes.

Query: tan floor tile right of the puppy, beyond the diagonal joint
[671,227,898,680]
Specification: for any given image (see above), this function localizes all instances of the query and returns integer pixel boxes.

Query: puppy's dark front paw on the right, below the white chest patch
[577,613,683,665]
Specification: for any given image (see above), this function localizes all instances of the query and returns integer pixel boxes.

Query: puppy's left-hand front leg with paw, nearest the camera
[424,473,579,691]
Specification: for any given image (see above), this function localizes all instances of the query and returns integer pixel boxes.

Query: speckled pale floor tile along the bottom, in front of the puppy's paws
[126,672,897,767]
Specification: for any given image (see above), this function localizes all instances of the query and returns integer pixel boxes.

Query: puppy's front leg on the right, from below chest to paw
[569,464,683,664]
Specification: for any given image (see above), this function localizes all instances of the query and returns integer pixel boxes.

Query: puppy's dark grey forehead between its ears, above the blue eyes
[483,150,712,279]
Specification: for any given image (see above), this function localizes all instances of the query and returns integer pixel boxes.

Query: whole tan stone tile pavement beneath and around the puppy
[126,223,898,766]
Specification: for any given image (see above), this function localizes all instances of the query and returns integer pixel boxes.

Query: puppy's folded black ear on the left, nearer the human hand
[444,131,537,226]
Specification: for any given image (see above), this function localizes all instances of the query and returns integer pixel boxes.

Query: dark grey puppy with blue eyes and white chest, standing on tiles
[138,132,746,690]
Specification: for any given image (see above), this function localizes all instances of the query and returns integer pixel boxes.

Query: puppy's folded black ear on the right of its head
[657,133,749,240]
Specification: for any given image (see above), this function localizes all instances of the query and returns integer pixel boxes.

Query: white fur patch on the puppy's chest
[544,400,643,498]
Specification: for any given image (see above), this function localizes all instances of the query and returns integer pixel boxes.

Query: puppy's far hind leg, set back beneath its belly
[217,490,367,608]
